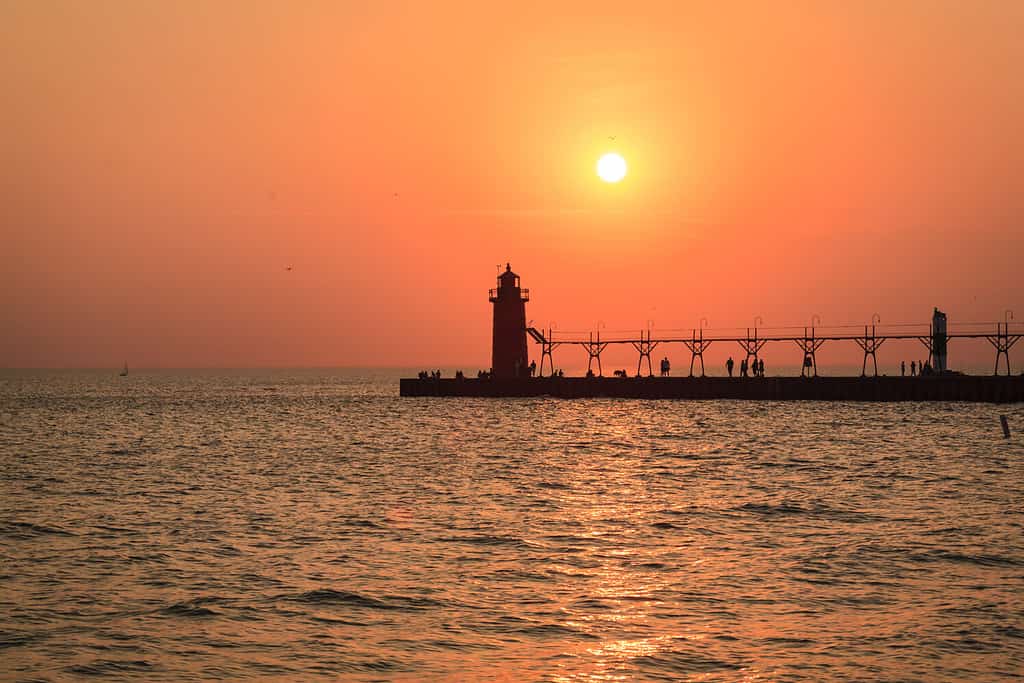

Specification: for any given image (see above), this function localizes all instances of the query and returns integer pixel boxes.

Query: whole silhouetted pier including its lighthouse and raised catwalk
[400,264,1024,402]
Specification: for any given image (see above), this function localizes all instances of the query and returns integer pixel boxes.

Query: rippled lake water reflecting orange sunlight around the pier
[0,371,1024,681]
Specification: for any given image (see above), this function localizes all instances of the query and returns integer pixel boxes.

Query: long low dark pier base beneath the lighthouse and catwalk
[399,375,1024,403]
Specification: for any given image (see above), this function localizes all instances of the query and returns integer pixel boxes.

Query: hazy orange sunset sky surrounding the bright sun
[0,0,1024,368]
